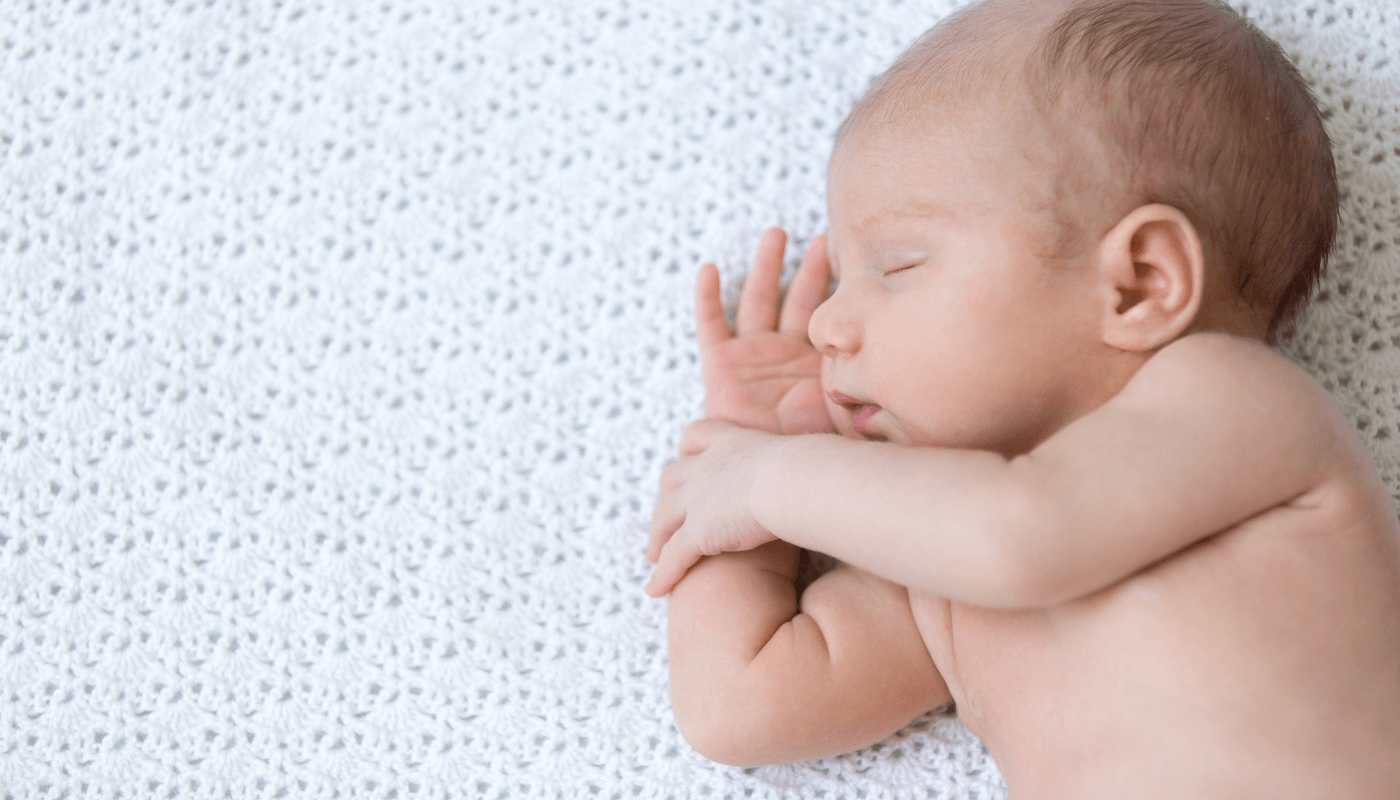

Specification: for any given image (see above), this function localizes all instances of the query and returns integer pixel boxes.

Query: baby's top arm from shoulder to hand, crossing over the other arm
[651,333,1340,607]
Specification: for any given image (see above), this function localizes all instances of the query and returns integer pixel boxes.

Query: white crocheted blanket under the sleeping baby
[0,0,1400,800]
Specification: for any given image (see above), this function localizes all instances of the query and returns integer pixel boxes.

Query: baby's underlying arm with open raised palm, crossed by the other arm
[668,228,949,765]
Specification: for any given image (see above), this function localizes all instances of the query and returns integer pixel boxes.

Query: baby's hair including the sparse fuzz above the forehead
[837,0,1338,342]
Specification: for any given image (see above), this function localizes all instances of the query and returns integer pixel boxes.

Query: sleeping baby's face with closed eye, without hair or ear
[809,115,1107,455]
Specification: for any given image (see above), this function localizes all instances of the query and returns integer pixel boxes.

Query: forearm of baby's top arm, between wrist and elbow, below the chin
[749,434,1028,605]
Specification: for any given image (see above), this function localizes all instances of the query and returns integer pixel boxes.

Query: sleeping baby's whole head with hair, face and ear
[811,0,1337,453]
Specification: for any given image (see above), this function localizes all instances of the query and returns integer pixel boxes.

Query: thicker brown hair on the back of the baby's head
[1028,0,1338,342]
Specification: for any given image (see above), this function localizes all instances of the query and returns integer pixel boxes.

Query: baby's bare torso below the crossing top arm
[910,439,1400,800]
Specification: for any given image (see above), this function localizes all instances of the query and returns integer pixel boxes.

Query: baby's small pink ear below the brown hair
[1098,203,1205,352]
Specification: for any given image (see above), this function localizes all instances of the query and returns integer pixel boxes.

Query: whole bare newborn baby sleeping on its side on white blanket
[648,0,1400,800]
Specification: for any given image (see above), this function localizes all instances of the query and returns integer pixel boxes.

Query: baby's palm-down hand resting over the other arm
[647,419,781,597]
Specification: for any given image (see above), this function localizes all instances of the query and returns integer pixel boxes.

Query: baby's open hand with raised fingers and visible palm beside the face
[696,228,834,433]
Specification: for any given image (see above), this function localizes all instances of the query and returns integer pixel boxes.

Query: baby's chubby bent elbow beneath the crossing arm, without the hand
[668,542,951,766]
